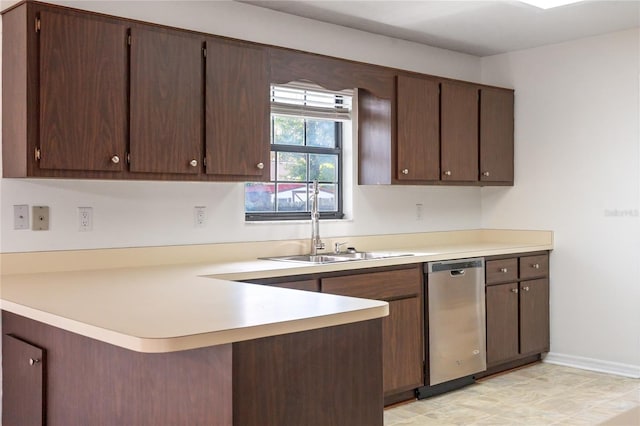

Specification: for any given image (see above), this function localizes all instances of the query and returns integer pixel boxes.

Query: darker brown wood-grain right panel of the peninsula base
[233,319,383,426]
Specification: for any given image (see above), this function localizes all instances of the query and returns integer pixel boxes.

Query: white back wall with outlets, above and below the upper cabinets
[0,1,480,252]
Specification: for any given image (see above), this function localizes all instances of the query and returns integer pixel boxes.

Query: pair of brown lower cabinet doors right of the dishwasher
[486,278,549,367]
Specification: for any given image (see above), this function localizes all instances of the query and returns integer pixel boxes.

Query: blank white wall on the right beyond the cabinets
[482,30,640,376]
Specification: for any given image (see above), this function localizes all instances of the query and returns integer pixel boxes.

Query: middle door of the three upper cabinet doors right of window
[440,83,478,182]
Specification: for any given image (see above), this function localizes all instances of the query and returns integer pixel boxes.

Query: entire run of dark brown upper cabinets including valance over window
[2,1,513,185]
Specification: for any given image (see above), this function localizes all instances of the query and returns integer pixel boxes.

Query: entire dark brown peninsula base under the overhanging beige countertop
[2,311,383,426]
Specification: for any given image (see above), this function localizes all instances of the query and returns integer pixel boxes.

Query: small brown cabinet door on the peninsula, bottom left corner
[2,334,44,426]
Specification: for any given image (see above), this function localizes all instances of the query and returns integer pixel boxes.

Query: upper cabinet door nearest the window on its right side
[397,76,440,180]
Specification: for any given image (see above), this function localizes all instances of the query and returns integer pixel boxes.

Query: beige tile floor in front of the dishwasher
[384,363,640,426]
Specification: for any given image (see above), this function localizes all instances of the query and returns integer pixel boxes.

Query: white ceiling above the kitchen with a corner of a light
[239,0,640,56]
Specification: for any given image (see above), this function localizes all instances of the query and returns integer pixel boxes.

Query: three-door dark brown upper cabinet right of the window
[358,74,513,185]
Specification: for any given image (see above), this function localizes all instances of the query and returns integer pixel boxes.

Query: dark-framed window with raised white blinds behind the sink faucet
[245,84,351,221]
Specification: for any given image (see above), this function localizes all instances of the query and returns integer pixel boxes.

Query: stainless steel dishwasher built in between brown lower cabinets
[418,258,487,398]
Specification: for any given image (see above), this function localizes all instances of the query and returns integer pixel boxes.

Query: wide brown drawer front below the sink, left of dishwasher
[322,268,422,299]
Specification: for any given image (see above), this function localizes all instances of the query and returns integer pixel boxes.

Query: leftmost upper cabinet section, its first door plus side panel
[2,5,127,177]
